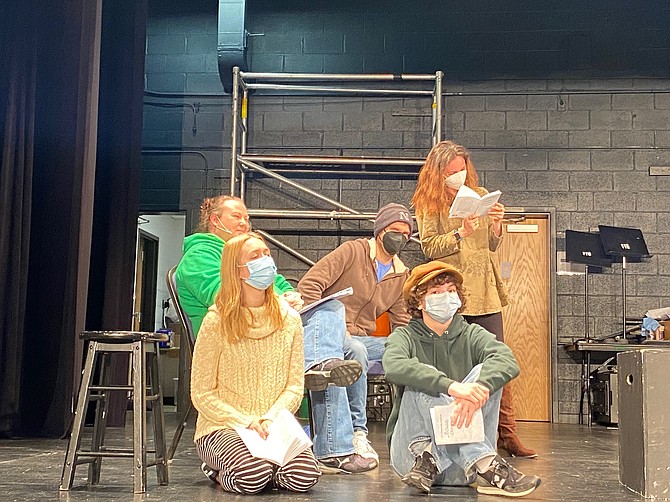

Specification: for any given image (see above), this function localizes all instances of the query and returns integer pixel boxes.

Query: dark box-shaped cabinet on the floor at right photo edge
[617,349,670,500]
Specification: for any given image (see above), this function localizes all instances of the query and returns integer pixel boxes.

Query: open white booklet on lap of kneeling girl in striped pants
[235,410,312,466]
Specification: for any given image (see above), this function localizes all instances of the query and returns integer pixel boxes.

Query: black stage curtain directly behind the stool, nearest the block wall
[86,0,147,426]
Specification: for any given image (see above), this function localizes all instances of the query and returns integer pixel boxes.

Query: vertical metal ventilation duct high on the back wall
[216,0,247,93]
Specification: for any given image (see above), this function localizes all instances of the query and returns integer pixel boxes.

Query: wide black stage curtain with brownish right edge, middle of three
[12,0,101,436]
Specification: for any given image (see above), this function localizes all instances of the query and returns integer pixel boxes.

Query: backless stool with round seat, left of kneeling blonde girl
[60,331,168,493]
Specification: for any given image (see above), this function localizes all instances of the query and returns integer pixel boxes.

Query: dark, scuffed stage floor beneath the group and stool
[0,413,644,502]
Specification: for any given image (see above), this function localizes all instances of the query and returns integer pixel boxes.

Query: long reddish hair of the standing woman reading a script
[412,141,479,213]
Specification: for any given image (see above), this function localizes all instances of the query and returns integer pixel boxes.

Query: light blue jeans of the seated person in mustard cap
[391,364,502,486]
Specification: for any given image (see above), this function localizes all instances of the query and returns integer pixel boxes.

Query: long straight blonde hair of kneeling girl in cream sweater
[214,232,284,342]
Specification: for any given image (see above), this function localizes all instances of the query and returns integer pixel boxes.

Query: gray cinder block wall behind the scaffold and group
[141,2,670,422]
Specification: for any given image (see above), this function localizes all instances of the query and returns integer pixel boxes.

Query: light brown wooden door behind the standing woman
[496,217,552,422]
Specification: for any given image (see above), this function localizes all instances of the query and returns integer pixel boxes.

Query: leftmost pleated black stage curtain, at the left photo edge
[0,3,36,436]
